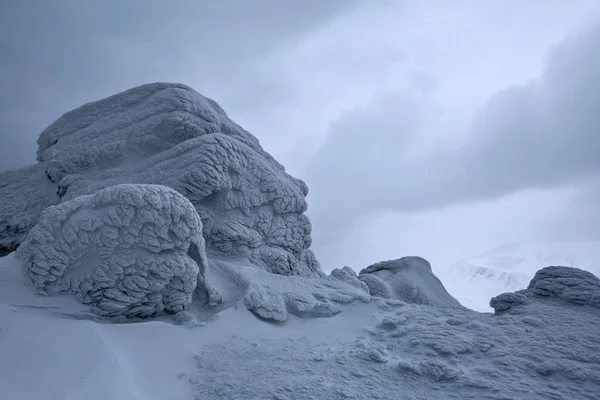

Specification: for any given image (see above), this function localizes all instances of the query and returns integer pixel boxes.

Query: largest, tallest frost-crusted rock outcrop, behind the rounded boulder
[0,83,324,277]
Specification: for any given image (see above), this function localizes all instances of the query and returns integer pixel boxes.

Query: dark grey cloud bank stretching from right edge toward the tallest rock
[307,20,600,241]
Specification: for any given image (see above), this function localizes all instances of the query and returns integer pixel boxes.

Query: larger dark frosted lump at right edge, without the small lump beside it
[527,266,600,308]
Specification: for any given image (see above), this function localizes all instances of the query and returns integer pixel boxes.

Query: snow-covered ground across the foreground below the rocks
[0,255,600,400]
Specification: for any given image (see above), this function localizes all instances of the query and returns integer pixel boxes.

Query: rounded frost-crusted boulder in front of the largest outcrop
[17,185,220,318]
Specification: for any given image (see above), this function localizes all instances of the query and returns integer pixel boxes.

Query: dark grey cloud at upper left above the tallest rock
[0,0,353,169]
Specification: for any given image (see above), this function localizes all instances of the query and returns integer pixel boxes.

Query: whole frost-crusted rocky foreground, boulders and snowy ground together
[0,84,600,400]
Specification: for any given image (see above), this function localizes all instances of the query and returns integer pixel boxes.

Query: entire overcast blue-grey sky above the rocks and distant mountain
[0,0,600,270]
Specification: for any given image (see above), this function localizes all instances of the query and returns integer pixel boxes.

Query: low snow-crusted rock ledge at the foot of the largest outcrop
[210,261,371,322]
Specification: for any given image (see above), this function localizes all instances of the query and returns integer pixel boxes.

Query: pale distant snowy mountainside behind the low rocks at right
[435,241,600,312]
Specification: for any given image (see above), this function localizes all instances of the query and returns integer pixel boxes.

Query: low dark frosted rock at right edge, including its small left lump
[490,266,600,313]
